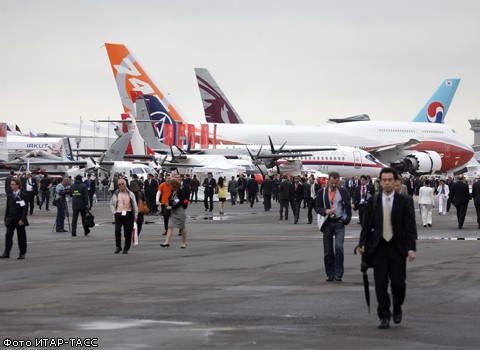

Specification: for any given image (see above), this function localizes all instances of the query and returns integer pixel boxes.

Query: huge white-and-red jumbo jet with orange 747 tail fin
[106,44,473,174]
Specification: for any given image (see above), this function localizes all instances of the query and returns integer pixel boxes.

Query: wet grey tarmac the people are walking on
[0,197,480,350]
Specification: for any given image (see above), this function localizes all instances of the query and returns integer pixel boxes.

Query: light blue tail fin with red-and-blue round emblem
[413,79,460,124]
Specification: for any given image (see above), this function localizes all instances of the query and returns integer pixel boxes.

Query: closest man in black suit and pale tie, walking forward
[358,168,416,329]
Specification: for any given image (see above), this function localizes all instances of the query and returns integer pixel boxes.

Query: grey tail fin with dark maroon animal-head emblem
[195,68,243,124]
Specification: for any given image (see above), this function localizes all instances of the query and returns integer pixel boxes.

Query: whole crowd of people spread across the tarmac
[0,168,480,329]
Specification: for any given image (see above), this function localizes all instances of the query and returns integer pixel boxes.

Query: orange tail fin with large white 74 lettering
[105,43,186,139]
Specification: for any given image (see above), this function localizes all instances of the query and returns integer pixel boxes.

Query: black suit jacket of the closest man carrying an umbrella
[359,192,416,257]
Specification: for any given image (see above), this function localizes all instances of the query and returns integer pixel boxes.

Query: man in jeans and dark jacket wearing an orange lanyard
[315,172,352,282]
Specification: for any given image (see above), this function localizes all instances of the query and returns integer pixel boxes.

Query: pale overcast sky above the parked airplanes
[0,0,480,143]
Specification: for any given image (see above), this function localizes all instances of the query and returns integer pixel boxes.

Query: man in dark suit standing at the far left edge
[0,177,28,259]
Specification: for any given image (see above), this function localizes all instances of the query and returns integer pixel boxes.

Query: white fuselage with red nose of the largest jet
[202,121,473,172]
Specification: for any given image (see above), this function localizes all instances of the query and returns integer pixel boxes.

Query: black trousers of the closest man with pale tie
[372,239,407,319]
